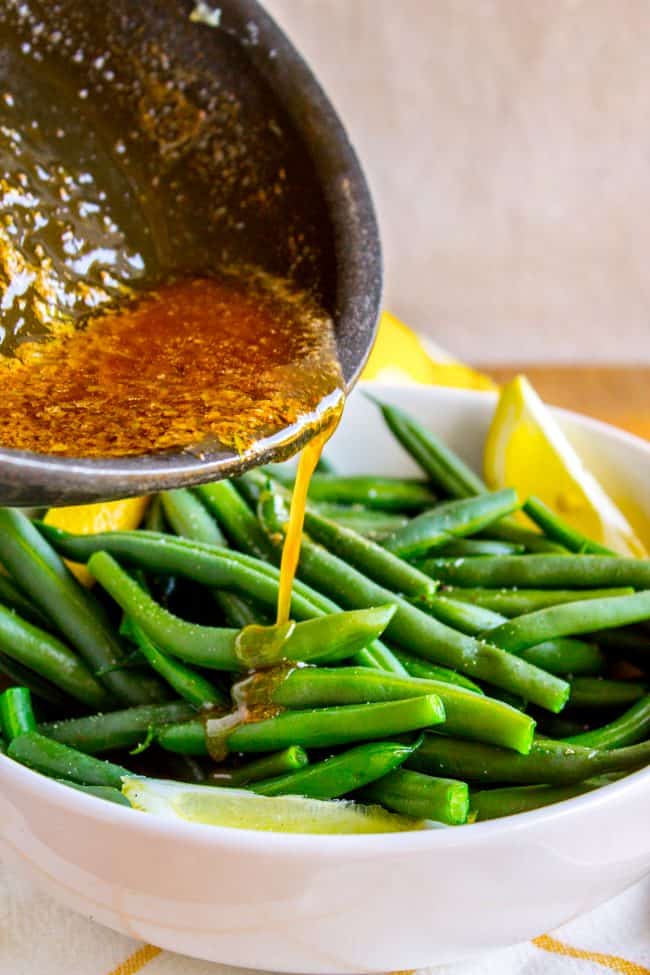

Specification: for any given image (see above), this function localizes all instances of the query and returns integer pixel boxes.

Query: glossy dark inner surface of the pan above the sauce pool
[0,0,334,352]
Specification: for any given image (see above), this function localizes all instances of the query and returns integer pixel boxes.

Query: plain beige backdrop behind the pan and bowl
[266,0,650,363]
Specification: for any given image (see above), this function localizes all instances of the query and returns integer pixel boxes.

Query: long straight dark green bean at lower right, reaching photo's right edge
[408,734,650,785]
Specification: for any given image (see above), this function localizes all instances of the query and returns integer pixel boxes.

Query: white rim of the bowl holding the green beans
[0,383,650,859]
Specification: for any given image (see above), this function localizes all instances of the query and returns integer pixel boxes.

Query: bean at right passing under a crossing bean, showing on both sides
[427,596,605,676]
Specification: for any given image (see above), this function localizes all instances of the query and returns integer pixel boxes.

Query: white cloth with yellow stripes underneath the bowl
[0,867,650,975]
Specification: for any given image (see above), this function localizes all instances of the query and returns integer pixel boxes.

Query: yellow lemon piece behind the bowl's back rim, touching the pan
[362,311,497,389]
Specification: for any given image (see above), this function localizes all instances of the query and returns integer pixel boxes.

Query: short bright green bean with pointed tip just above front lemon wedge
[252,741,413,799]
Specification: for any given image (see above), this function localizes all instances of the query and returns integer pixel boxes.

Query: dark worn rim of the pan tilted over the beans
[0,0,383,505]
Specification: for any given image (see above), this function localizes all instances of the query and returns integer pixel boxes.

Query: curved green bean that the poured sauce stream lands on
[88,552,395,671]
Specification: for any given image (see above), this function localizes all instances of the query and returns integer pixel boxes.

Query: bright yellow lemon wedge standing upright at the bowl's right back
[484,376,645,557]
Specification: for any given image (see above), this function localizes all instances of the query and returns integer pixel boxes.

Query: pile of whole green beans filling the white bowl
[0,396,650,826]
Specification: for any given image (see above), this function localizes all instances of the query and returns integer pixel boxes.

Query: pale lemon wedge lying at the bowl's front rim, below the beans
[122,777,426,834]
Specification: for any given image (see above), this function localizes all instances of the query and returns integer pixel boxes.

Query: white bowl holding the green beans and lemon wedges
[0,387,650,975]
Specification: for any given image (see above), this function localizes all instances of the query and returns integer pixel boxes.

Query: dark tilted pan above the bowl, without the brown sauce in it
[0,0,381,505]
